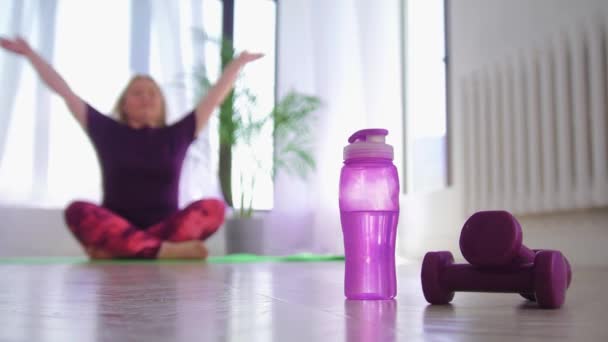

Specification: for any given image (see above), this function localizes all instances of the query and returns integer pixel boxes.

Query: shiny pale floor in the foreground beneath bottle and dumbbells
[0,262,608,342]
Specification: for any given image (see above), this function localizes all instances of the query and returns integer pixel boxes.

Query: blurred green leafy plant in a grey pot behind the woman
[195,37,321,254]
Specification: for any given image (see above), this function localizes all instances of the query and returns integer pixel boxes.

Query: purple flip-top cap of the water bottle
[344,128,393,160]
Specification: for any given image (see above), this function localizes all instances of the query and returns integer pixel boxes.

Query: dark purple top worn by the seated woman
[87,104,196,229]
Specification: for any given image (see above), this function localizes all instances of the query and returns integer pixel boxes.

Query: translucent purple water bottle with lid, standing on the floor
[340,129,399,299]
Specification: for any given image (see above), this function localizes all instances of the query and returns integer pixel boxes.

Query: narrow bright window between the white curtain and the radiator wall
[402,0,448,192]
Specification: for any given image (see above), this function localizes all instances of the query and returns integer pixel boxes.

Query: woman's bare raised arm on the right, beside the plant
[195,51,263,135]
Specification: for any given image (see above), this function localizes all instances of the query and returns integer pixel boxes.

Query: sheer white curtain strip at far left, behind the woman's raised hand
[0,0,57,206]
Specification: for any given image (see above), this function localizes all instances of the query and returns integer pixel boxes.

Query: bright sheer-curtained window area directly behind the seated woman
[0,0,221,208]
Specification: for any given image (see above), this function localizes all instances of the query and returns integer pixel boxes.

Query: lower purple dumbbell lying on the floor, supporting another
[421,251,568,309]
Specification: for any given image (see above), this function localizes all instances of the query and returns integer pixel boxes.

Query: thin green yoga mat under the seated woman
[0,253,344,265]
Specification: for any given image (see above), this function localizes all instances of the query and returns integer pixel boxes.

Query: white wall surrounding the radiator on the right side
[408,0,608,265]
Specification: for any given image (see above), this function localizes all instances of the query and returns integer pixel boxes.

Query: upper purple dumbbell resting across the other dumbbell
[460,211,572,300]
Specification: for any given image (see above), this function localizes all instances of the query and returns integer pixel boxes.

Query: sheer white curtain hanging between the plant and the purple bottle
[267,0,403,253]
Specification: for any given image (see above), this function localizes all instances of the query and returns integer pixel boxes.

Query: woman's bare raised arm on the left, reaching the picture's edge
[0,38,87,128]
